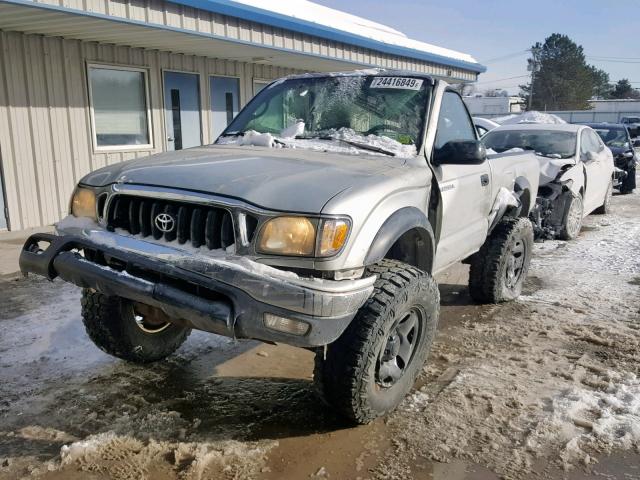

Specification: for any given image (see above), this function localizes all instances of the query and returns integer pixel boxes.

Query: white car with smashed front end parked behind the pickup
[482,124,614,240]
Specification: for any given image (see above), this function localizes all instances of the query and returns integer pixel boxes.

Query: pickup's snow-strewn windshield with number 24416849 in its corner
[218,75,431,156]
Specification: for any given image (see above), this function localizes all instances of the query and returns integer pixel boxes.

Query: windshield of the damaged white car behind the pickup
[482,130,576,158]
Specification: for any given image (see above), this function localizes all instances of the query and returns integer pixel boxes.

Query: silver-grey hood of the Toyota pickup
[80,145,406,213]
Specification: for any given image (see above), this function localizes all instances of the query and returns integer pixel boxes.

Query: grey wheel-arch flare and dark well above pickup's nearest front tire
[365,207,435,273]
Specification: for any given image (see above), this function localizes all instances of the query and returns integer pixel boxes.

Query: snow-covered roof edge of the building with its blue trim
[165,0,487,73]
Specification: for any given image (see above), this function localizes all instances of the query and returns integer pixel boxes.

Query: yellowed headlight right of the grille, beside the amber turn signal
[258,217,316,256]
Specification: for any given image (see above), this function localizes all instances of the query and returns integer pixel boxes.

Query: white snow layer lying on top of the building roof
[233,0,477,63]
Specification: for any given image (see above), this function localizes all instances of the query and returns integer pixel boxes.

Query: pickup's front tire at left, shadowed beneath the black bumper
[82,289,191,363]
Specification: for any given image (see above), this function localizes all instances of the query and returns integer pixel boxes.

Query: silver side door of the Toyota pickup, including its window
[433,91,492,271]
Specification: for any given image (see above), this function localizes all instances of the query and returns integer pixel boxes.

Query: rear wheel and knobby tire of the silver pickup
[469,218,533,303]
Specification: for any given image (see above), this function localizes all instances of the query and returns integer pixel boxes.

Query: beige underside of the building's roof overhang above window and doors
[0,0,370,71]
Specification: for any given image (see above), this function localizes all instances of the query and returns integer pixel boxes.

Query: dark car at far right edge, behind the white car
[586,123,640,194]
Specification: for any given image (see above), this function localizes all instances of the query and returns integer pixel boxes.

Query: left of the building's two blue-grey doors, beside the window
[164,72,202,150]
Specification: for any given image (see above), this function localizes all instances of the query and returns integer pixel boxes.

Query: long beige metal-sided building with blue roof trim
[0,0,484,230]
